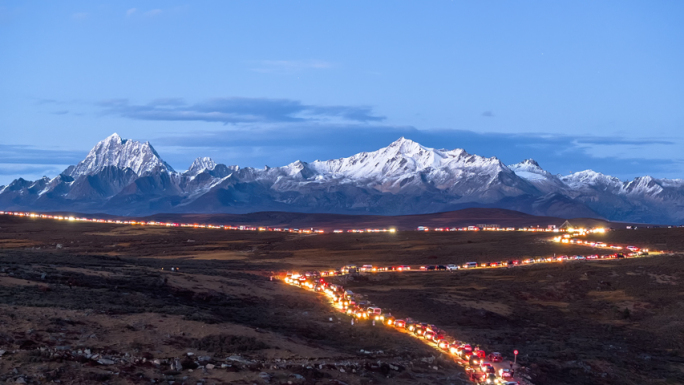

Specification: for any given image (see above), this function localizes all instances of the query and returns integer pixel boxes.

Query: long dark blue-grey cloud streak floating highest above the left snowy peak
[100,97,385,124]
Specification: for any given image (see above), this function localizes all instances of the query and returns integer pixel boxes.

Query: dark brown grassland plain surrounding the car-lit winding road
[0,213,684,384]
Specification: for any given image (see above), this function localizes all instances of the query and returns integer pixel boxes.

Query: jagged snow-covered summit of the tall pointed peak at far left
[64,133,173,178]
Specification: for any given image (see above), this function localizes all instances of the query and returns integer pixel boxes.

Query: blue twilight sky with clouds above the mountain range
[0,0,684,185]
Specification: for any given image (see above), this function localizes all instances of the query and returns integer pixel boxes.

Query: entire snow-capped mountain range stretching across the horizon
[0,134,684,223]
